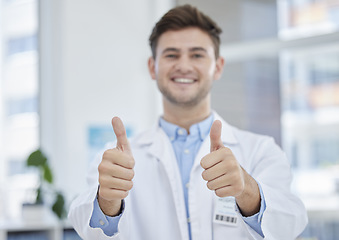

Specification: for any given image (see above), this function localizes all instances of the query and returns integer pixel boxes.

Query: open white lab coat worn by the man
[69,113,307,240]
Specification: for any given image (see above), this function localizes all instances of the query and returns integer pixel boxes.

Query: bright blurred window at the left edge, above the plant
[0,0,39,218]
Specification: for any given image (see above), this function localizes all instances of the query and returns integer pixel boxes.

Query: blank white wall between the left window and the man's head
[40,0,173,204]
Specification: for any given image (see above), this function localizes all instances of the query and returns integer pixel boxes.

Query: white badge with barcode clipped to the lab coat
[213,197,238,227]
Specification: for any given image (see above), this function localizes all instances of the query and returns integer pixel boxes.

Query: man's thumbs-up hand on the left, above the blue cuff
[98,117,135,216]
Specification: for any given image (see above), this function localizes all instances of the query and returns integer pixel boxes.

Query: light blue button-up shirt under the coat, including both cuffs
[90,115,266,239]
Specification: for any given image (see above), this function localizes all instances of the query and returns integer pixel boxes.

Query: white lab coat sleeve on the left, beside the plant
[68,147,122,240]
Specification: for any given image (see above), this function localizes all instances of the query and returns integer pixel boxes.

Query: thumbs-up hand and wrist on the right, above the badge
[200,120,260,216]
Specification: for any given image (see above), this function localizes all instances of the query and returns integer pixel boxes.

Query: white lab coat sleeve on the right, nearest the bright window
[250,138,307,239]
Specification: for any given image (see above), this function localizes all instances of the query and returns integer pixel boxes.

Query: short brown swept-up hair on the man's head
[149,4,222,58]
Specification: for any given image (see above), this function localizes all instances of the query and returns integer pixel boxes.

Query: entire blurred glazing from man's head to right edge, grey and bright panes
[210,0,339,240]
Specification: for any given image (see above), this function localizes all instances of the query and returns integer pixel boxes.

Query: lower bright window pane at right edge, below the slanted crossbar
[281,43,339,209]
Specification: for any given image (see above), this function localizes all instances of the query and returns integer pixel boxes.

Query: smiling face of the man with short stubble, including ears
[148,27,223,107]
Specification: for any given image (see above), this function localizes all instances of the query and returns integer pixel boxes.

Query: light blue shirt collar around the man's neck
[159,114,214,142]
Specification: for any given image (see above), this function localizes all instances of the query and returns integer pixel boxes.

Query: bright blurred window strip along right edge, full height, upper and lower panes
[278,0,339,240]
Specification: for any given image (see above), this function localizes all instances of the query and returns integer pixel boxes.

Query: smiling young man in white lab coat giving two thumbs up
[69,5,307,240]
